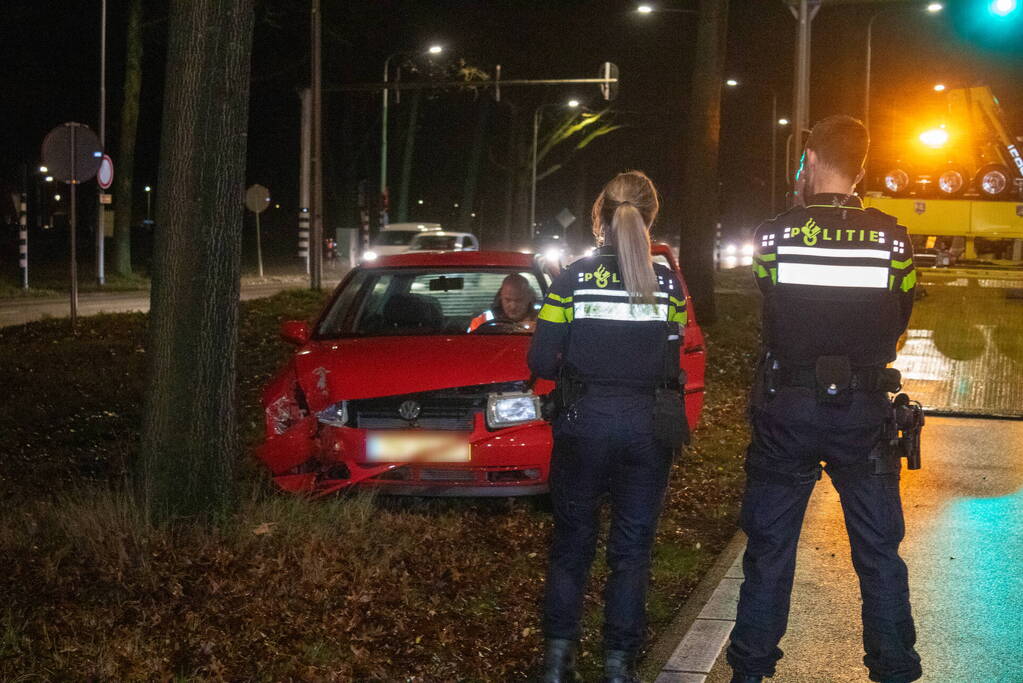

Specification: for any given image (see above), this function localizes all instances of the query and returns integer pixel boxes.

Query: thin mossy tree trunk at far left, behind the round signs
[114,0,142,275]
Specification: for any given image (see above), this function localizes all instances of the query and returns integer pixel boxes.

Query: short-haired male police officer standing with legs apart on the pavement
[727,116,921,683]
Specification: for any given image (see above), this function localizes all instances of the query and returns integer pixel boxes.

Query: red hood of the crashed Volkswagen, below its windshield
[295,334,533,410]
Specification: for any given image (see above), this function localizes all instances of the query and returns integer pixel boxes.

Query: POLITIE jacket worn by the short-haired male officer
[753,193,917,367]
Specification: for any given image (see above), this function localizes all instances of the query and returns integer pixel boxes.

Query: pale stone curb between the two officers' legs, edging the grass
[640,531,746,683]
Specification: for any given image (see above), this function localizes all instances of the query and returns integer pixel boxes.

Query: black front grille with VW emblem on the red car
[349,396,482,431]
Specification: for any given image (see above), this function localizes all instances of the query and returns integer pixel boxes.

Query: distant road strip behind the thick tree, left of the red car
[0,280,338,327]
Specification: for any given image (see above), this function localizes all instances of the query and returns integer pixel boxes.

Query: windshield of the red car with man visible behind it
[315,268,544,339]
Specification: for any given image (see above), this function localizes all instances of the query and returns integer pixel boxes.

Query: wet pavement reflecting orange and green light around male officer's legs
[650,417,1023,683]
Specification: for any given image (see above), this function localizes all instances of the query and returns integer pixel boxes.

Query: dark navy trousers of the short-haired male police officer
[726,388,921,683]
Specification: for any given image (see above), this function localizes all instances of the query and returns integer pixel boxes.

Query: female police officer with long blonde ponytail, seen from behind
[529,171,686,683]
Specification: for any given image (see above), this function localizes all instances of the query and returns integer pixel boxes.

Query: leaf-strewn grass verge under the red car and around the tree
[0,265,758,681]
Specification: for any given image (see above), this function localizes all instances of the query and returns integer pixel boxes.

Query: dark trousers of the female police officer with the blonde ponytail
[543,390,672,653]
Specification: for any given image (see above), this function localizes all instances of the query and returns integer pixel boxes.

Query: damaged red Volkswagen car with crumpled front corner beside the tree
[258,244,705,496]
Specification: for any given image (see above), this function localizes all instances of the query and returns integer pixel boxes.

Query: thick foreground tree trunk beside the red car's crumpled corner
[132,0,254,523]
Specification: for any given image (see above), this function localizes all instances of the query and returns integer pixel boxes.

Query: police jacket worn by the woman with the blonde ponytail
[528,246,686,389]
